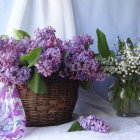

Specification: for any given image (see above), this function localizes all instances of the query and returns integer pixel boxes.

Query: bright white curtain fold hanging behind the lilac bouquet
[7,0,75,39]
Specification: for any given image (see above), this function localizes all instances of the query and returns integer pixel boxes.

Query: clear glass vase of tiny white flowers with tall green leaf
[97,29,140,116]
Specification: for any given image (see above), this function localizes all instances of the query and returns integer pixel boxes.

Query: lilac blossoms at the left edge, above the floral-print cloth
[0,38,31,85]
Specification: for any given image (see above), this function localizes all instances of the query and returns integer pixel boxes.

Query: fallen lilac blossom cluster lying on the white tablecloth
[79,115,109,133]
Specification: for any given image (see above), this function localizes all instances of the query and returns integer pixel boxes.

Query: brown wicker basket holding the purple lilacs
[19,77,78,127]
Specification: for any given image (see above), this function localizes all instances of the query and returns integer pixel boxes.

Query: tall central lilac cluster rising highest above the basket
[33,27,62,77]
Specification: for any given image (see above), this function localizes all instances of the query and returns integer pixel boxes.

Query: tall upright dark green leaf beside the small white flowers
[96,29,110,58]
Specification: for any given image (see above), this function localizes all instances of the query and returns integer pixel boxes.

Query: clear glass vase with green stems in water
[108,78,140,117]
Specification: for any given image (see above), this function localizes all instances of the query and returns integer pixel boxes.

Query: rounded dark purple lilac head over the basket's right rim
[61,50,99,80]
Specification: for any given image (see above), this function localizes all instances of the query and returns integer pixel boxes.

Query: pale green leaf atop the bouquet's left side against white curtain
[12,28,31,40]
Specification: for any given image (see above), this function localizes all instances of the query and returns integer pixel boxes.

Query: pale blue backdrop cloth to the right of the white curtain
[72,0,140,50]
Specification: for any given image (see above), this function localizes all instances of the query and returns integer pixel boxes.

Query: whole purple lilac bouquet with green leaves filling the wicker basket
[0,27,104,93]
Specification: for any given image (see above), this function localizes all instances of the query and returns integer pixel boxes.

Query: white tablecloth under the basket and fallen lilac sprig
[22,88,140,140]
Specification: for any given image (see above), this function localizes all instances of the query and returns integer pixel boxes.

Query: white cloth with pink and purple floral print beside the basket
[0,85,26,140]
